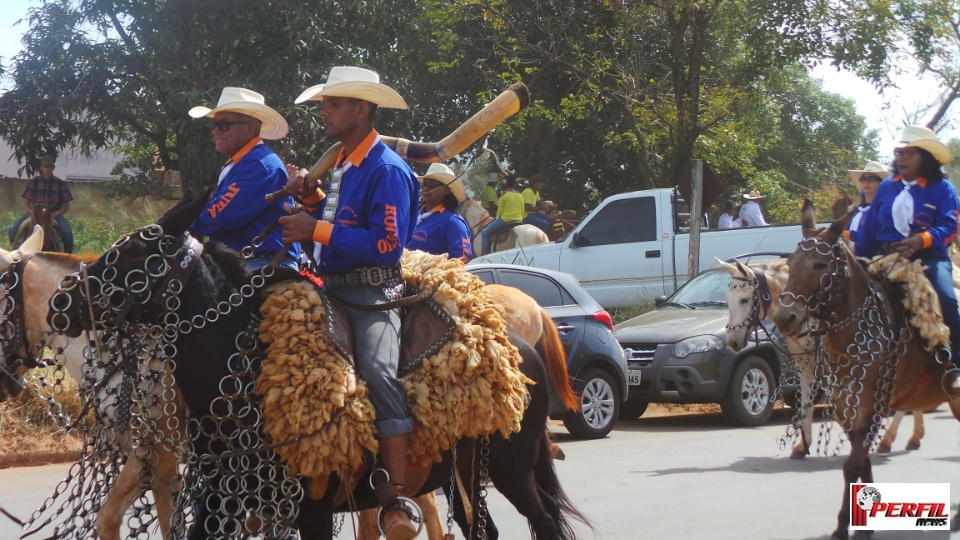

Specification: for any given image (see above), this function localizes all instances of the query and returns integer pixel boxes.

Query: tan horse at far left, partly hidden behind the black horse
[0,225,183,540]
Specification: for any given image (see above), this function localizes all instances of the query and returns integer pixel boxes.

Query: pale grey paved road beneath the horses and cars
[0,407,960,540]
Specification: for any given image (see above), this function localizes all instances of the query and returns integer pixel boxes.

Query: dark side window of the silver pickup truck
[579,197,657,246]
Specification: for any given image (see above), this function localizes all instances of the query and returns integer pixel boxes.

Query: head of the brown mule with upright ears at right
[773,200,861,336]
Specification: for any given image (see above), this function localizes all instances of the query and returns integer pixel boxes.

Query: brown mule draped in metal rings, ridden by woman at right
[773,201,960,539]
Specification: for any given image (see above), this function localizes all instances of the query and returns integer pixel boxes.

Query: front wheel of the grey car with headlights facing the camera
[720,356,775,426]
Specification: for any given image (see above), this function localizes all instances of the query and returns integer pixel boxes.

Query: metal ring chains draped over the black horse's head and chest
[18,225,303,538]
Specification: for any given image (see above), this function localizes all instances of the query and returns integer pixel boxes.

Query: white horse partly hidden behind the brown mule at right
[718,260,925,459]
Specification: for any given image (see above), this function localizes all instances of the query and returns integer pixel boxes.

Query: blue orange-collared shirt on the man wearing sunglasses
[190,137,300,261]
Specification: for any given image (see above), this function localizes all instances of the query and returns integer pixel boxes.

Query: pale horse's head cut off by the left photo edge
[0,226,43,402]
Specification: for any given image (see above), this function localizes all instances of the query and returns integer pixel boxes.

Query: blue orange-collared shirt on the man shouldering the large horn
[303,130,420,274]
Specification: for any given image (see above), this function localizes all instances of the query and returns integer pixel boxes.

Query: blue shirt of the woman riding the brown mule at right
[855,176,960,259]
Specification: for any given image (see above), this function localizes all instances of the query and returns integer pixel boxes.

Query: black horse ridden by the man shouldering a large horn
[51,192,589,538]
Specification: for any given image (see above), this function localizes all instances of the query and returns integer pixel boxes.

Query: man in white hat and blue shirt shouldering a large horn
[280,66,419,540]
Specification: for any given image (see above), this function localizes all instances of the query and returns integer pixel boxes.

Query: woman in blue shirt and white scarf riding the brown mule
[856,126,960,395]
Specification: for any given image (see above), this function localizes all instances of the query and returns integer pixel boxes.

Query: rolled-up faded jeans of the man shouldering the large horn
[329,285,413,439]
